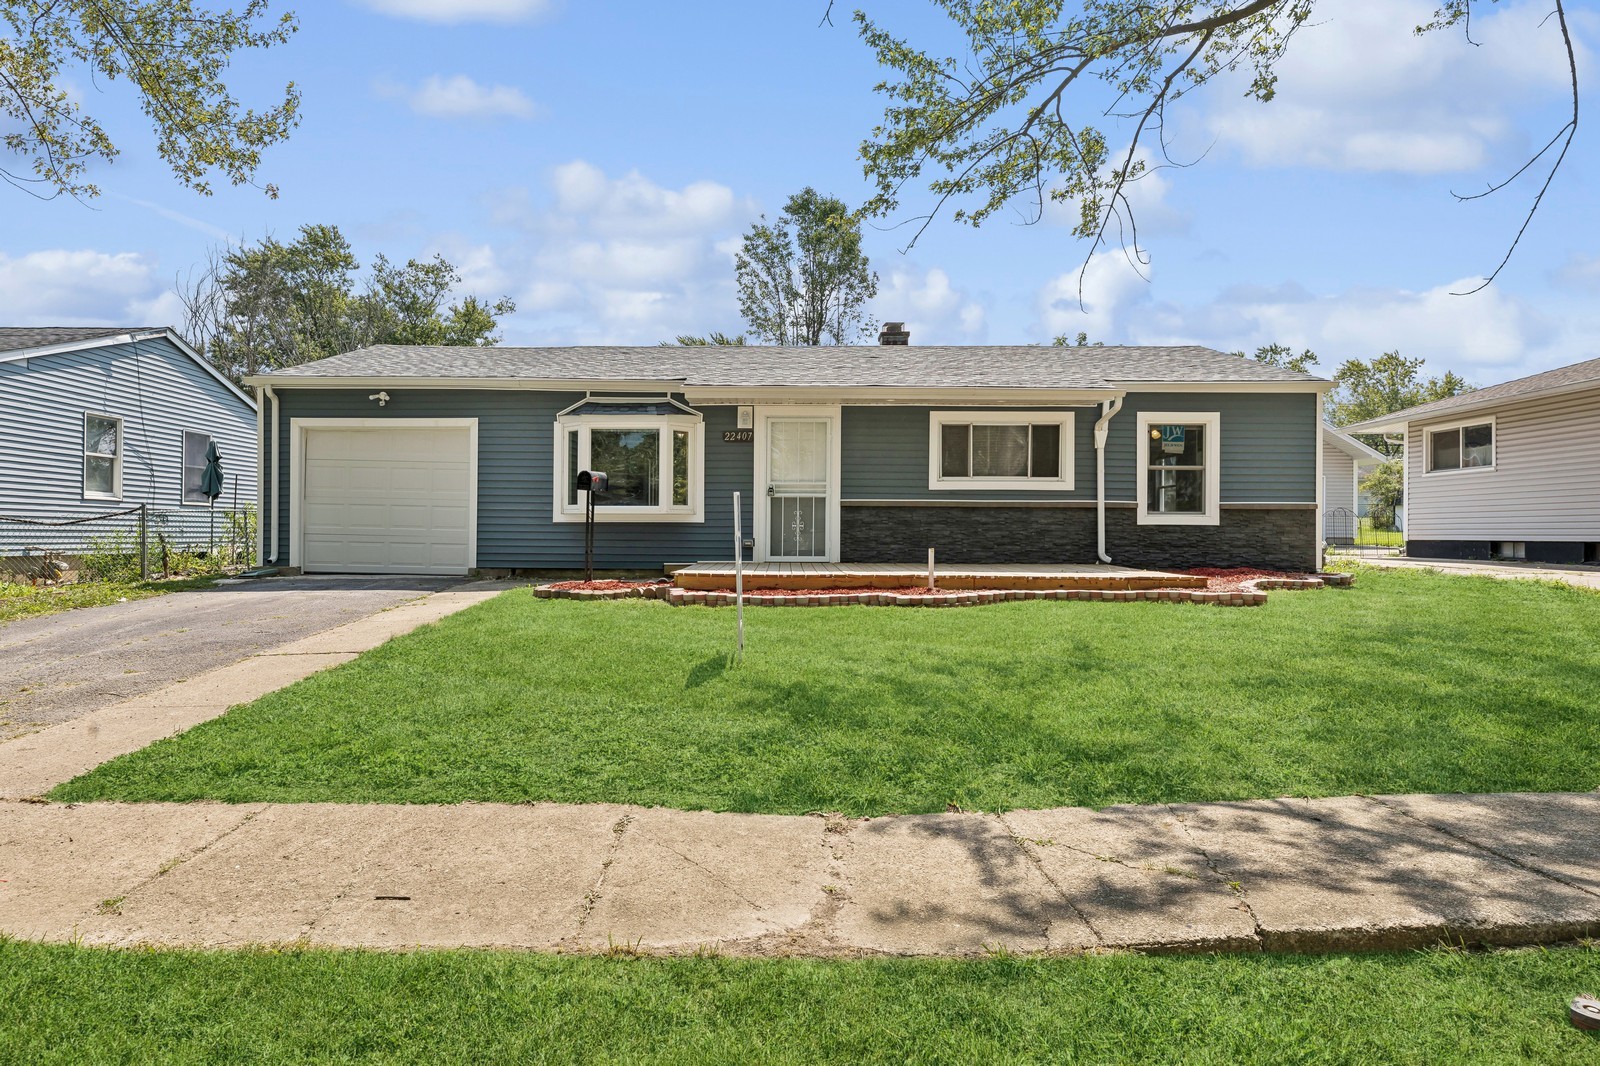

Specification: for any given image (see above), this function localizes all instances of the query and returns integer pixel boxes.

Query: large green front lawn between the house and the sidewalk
[51,570,1600,815]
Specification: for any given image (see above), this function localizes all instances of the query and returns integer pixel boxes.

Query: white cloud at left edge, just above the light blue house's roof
[0,248,167,325]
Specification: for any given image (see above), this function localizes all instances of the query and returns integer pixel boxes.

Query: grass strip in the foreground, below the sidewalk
[0,941,1600,1066]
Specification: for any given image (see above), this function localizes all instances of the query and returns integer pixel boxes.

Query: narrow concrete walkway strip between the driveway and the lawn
[0,581,517,800]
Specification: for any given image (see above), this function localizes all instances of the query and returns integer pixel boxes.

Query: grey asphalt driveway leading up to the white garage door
[0,578,459,741]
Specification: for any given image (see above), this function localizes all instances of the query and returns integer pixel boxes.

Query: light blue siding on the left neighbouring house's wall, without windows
[0,332,256,517]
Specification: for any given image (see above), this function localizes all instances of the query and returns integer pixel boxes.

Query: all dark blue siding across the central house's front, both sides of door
[262,387,1320,570]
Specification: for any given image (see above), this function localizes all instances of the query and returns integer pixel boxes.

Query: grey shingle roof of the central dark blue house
[259,344,1318,389]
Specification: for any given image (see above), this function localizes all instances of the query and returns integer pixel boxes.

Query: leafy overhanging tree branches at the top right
[856,0,1578,285]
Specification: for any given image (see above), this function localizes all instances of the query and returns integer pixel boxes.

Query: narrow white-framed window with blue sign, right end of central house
[1136,411,1222,525]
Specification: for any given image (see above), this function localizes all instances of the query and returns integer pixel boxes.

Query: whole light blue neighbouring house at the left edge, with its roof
[0,327,256,519]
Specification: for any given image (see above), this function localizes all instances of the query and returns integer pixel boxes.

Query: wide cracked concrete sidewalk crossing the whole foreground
[0,787,1600,957]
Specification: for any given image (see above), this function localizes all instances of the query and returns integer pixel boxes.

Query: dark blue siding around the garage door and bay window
[267,389,752,570]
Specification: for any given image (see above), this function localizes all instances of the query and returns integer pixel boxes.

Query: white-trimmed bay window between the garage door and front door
[554,399,706,522]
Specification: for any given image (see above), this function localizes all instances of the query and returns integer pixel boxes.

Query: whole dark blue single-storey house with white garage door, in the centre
[246,323,1330,573]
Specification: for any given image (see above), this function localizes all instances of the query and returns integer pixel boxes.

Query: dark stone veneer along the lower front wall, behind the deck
[838,504,1318,570]
